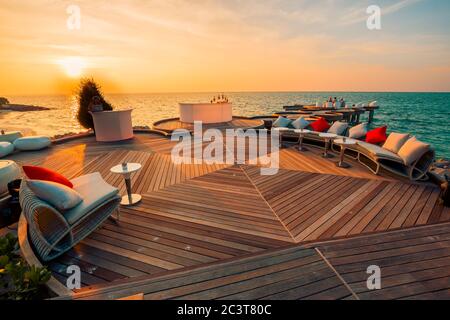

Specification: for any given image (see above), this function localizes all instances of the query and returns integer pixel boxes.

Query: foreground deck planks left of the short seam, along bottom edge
[67,247,351,300]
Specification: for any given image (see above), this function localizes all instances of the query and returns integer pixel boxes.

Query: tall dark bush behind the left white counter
[77,79,113,129]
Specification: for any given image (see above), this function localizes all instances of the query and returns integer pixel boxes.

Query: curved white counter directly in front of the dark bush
[91,109,133,142]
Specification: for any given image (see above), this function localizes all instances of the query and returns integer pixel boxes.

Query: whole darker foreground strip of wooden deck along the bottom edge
[65,223,450,300]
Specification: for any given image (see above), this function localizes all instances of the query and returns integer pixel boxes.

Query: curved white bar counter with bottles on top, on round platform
[180,103,233,124]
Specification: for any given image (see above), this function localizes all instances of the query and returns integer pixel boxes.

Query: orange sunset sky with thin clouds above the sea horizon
[0,0,450,96]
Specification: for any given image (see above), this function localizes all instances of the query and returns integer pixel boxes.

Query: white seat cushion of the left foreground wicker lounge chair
[64,172,119,225]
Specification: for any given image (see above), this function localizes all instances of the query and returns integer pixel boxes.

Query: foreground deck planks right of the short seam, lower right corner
[314,223,450,299]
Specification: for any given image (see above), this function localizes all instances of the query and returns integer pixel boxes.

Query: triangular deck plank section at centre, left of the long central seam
[144,166,292,241]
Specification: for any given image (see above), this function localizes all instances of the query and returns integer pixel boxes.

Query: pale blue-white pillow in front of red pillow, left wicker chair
[27,180,82,211]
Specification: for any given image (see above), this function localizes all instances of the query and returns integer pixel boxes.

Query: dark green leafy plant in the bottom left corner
[0,234,51,300]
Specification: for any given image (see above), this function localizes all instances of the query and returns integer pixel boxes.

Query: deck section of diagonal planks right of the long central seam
[244,166,445,242]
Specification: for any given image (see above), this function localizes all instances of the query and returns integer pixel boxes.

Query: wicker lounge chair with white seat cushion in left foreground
[19,173,121,261]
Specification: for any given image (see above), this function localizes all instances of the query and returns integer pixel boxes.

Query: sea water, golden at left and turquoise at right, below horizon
[0,92,450,158]
